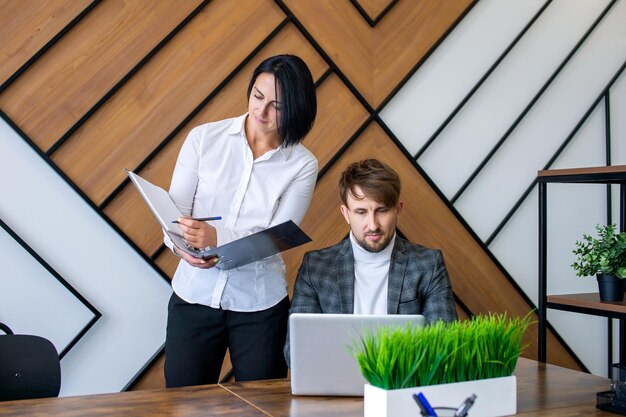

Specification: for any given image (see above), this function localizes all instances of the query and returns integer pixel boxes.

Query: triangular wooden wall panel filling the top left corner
[0,0,91,85]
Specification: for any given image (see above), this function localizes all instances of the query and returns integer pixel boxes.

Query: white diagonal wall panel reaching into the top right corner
[455,2,626,239]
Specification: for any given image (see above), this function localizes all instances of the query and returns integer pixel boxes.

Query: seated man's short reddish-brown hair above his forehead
[339,159,401,207]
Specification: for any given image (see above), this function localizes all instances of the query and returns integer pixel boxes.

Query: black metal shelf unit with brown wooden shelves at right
[537,165,626,365]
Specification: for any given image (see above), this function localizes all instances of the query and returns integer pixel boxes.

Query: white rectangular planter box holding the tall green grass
[364,376,517,417]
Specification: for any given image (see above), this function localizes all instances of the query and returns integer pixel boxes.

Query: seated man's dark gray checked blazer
[284,235,457,365]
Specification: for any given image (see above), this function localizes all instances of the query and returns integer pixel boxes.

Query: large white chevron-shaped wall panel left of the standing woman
[0,116,171,395]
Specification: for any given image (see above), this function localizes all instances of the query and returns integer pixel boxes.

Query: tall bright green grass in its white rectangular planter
[353,313,531,417]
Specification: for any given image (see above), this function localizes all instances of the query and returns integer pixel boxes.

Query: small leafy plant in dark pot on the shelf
[572,224,626,301]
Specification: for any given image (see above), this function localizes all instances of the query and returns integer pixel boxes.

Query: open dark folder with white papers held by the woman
[127,170,311,269]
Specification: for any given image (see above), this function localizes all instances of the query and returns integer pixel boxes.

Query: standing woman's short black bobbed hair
[248,55,317,146]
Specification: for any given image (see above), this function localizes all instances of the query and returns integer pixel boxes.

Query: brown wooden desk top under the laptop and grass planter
[0,358,616,417]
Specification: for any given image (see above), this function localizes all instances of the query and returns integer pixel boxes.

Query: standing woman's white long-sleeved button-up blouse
[164,114,317,311]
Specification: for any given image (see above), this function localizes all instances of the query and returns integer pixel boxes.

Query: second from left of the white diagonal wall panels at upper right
[418,0,606,198]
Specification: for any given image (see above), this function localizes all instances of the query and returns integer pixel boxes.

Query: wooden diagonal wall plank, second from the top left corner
[0,0,200,151]
